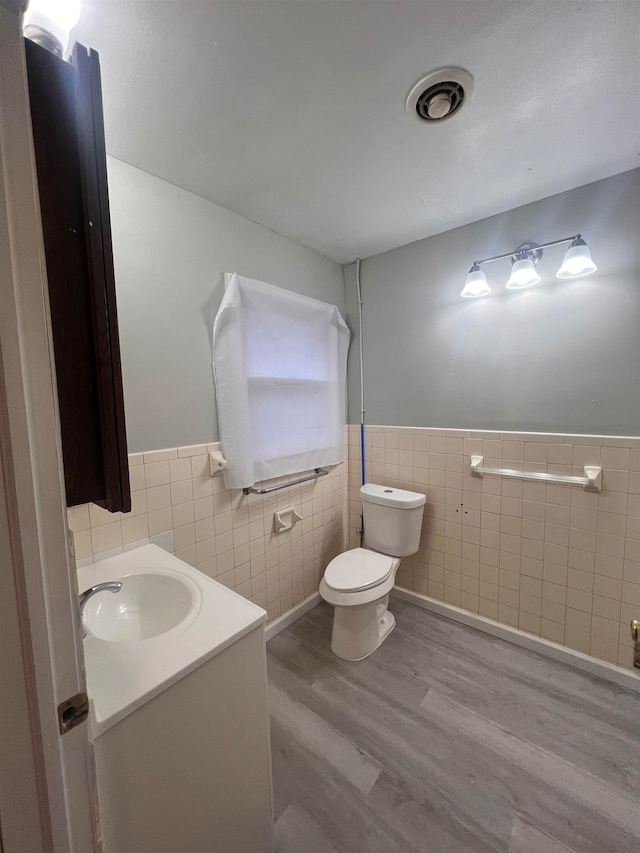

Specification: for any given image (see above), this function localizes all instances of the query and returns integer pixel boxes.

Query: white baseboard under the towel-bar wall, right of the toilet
[391,586,640,692]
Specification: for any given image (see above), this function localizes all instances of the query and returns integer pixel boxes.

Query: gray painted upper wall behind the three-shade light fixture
[345,169,640,435]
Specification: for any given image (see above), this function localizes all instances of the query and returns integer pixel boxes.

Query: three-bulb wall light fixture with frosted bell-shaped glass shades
[460,234,598,299]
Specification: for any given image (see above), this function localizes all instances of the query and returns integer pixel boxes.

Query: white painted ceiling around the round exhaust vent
[73,0,640,262]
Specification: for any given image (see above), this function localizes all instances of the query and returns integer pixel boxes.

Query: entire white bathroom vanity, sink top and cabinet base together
[78,545,273,853]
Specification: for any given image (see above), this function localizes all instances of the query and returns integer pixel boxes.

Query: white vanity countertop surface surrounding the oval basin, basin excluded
[78,545,267,738]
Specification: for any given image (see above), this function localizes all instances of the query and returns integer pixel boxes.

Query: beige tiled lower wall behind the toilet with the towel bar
[349,426,640,668]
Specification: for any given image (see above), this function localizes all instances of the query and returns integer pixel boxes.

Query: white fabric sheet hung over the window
[213,273,350,489]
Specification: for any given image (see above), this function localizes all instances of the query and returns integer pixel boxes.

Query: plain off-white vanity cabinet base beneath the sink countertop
[93,625,273,853]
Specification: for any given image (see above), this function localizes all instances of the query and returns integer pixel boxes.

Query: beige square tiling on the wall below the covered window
[68,444,348,620]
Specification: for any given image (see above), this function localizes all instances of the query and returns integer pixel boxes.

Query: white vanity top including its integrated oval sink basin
[78,544,267,738]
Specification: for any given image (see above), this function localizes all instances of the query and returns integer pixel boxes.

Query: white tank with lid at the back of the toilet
[360,483,427,557]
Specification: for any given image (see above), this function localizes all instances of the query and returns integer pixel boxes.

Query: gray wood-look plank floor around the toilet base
[267,599,640,853]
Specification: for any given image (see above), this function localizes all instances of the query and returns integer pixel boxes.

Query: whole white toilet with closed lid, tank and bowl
[320,483,427,660]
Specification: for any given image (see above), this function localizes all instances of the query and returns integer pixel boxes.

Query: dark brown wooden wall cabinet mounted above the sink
[25,39,131,512]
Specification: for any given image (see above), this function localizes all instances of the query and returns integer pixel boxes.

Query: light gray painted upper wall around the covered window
[108,157,345,452]
